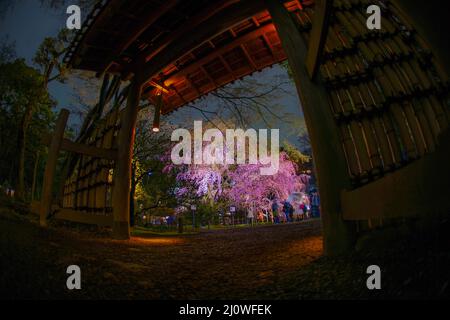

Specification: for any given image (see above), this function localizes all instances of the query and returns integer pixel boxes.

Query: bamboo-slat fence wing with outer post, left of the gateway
[38,109,121,226]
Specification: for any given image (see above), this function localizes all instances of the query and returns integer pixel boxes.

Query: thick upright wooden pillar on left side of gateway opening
[112,76,142,240]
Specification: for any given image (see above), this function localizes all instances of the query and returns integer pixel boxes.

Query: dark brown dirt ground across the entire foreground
[0,210,450,299]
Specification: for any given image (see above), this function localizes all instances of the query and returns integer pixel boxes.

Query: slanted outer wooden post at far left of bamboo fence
[39,109,69,227]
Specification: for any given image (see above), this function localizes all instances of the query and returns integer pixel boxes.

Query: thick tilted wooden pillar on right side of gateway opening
[265,0,356,255]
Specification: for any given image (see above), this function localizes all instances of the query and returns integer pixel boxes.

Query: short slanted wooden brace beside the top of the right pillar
[306,0,333,79]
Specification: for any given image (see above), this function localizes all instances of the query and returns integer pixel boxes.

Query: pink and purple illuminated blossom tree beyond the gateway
[166,152,305,209]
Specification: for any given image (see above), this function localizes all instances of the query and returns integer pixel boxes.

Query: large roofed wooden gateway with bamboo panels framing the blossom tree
[36,0,450,254]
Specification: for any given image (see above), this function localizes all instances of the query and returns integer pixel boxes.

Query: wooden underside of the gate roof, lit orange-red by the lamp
[66,0,313,113]
